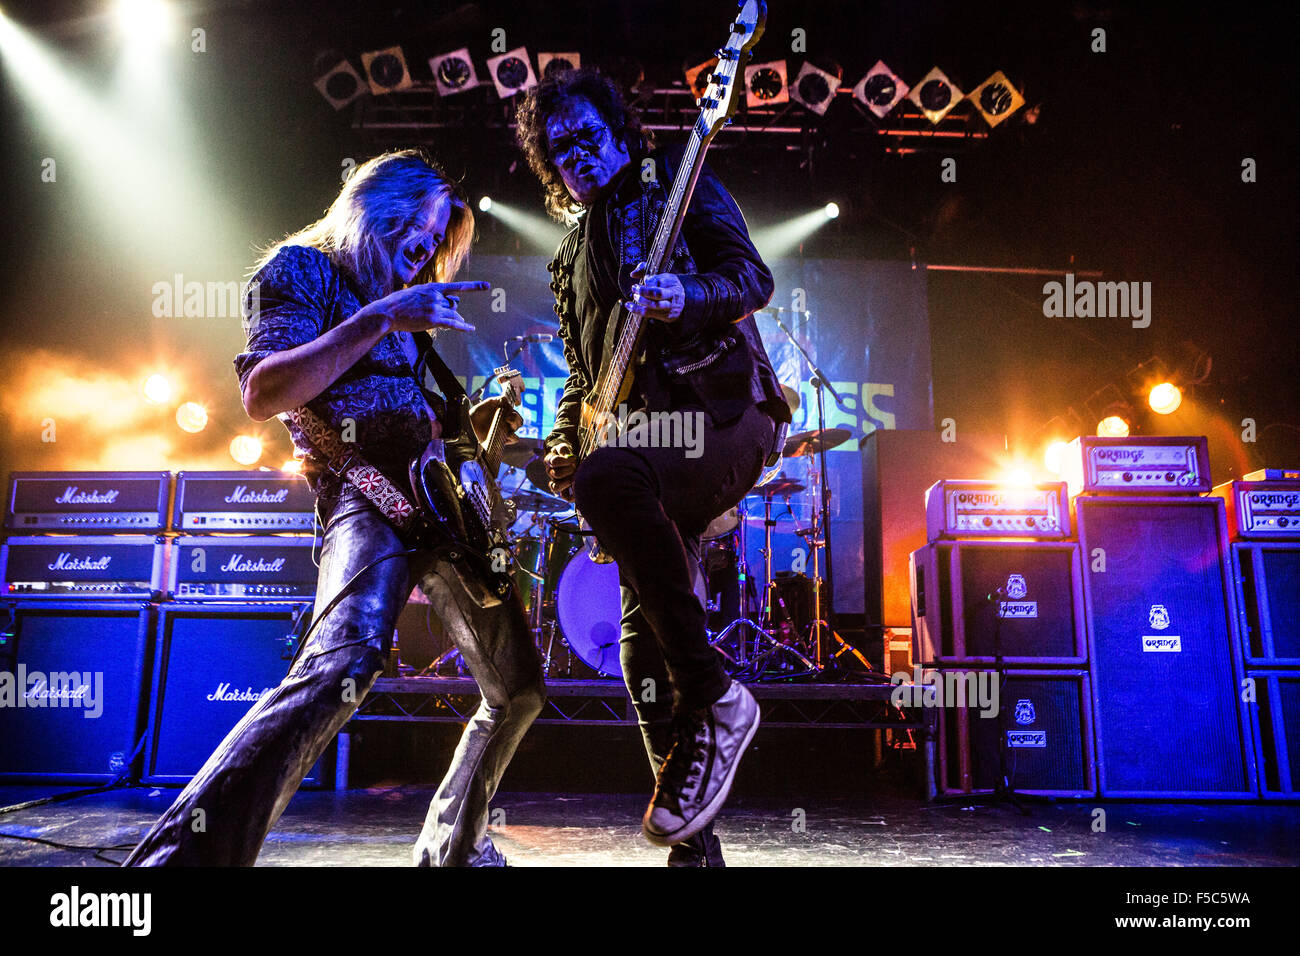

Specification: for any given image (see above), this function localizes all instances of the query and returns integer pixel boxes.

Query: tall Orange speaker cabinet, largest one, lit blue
[1075,497,1256,797]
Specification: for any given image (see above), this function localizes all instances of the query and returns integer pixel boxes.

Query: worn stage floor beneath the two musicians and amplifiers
[0,786,1300,866]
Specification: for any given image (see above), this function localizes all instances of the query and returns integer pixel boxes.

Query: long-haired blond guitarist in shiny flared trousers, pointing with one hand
[127,151,545,866]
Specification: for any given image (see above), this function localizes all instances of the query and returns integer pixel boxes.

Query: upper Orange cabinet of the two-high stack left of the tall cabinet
[911,541,1087,666]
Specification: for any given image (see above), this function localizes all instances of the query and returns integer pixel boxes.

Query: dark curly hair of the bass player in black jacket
[515,66,654,222]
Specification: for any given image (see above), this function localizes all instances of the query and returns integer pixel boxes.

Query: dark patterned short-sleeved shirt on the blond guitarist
[234,246,434,497]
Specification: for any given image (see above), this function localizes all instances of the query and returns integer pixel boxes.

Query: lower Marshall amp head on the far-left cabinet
[0,535,166,601]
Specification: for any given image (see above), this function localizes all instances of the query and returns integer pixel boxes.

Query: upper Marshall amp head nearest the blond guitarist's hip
[172,471,316,533]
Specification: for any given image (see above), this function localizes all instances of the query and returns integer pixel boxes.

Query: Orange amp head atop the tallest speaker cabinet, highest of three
[1063,434,1210,496]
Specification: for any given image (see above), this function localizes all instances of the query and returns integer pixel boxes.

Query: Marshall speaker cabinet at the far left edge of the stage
[0,600,153,783]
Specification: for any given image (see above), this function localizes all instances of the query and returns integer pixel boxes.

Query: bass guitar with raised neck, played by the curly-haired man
[577,0,767,563]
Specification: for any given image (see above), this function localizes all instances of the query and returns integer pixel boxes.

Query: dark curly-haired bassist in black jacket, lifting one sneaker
[519,68,790,866]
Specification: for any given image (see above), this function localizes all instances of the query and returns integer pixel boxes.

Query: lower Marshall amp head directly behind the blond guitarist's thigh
[168,536,317,601]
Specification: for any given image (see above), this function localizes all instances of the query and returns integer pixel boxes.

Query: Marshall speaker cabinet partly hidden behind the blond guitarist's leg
[142,602,322,786]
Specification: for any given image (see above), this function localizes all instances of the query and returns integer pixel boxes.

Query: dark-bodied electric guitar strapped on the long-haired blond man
[407,365,524,574]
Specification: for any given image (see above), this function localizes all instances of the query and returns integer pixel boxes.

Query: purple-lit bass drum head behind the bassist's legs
[555,548,706,680]
